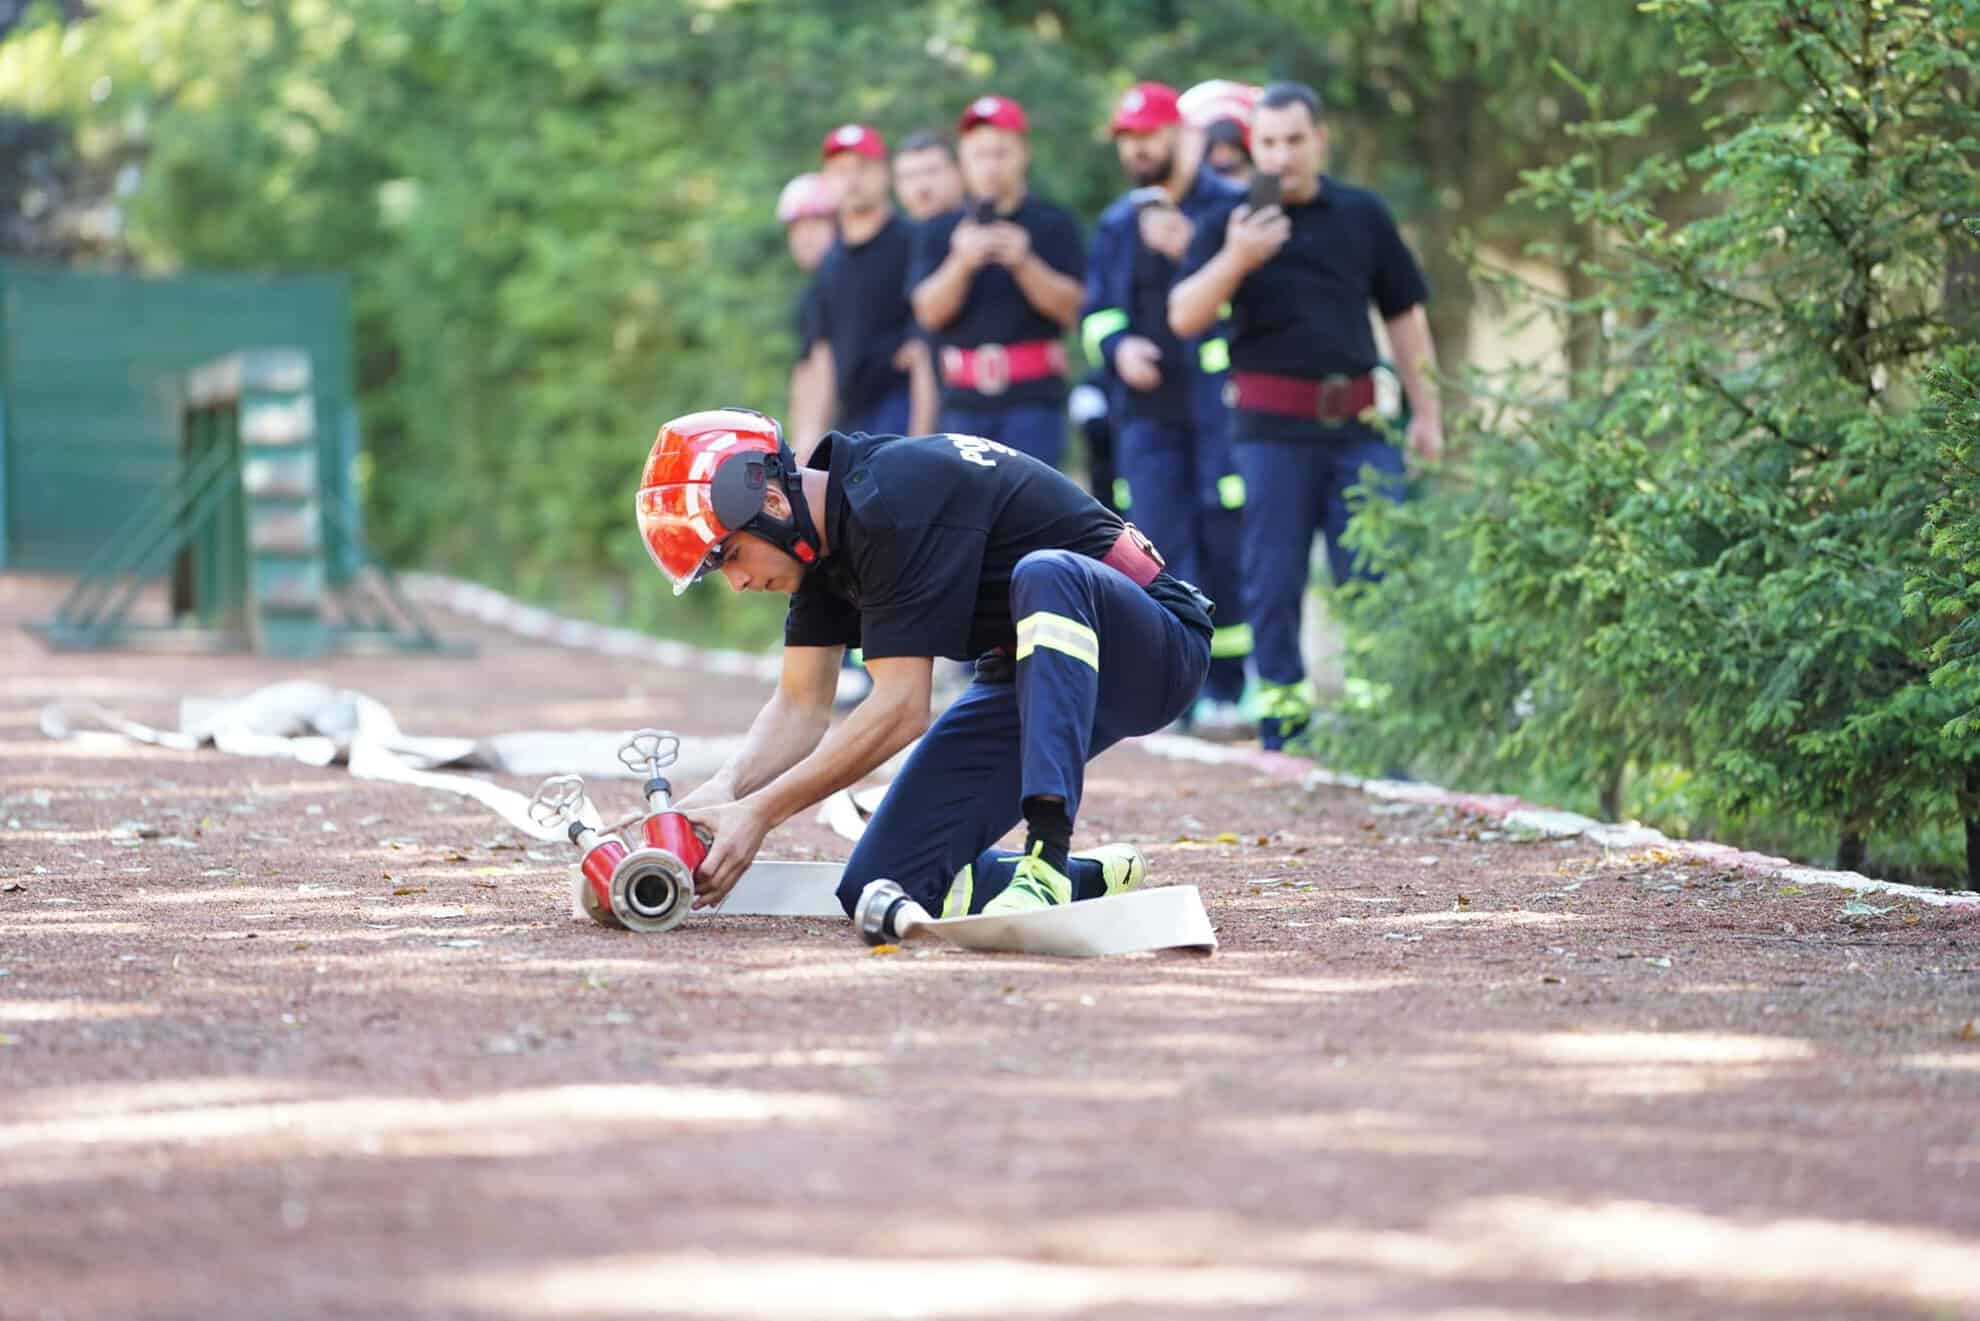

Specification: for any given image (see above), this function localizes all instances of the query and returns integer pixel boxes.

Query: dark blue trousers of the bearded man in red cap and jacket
[1115,418,1247,701]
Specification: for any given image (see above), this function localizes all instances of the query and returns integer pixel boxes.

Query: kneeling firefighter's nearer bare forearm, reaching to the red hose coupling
[687,656,935,907]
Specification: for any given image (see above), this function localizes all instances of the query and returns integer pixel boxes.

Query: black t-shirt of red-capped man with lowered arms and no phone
[814,216,915,416]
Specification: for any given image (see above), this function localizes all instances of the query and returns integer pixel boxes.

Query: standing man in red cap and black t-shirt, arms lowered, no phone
[792,125,933,450]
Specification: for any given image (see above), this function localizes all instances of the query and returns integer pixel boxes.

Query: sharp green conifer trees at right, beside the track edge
[1331,0,1980,887]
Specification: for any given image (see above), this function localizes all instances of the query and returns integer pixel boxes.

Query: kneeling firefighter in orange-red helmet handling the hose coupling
[638,408,1212,917]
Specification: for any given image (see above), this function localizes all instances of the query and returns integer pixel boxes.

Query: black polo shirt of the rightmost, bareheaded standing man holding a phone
[1178,174,1430,431]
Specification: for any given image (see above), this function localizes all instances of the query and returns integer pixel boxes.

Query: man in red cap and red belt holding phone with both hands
[909,97,1085,465]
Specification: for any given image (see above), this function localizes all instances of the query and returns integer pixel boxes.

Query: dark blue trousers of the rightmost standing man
[1232,422,1404,683]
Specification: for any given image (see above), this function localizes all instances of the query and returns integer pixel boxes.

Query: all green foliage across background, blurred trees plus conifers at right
[0,0,1980,887]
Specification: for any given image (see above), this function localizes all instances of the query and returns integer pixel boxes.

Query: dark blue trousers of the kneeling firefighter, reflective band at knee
[840,551,1210,913]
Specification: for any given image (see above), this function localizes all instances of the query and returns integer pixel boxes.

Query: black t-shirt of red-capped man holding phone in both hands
[907,196,1087,408]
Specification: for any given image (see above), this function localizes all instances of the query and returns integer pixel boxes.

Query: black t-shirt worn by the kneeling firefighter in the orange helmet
[784,432,1212,660]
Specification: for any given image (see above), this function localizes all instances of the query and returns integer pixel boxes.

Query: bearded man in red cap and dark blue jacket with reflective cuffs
[1081,83,1251,729]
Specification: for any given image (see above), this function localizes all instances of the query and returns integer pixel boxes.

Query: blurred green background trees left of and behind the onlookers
[0,0,1702,641]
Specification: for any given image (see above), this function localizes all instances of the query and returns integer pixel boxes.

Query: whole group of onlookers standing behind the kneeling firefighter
[778,79,1443,749]
